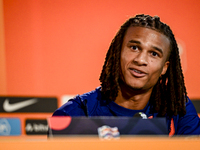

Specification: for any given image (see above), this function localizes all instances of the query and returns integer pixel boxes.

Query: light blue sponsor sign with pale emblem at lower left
[0,118,21,136]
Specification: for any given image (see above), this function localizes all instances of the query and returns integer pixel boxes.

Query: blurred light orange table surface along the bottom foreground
[0,136,200,150]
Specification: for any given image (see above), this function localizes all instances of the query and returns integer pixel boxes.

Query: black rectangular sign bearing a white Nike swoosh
[0,97,58,113]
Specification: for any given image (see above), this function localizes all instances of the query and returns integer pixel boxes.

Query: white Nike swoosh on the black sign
[3,98,38,112]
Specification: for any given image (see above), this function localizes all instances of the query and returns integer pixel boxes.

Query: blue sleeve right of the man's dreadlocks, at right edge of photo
[175,99,200,135]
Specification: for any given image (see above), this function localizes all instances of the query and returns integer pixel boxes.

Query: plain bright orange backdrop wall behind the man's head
[1,0,200,98]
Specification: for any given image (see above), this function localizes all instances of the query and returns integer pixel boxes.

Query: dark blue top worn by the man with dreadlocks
[53,87,200,135]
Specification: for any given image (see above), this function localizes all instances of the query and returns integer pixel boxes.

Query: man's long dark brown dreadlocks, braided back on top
[99,14,187,116]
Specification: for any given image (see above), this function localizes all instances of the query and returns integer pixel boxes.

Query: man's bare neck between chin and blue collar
[115,83,152,110]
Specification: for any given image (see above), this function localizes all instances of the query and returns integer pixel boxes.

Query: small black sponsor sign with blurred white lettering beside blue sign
[25,119,48,135]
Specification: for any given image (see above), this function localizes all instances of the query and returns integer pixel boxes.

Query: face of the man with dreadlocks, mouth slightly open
[121,27,170,91]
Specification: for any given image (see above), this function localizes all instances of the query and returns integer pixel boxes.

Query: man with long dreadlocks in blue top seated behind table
[53,15,200,135]
